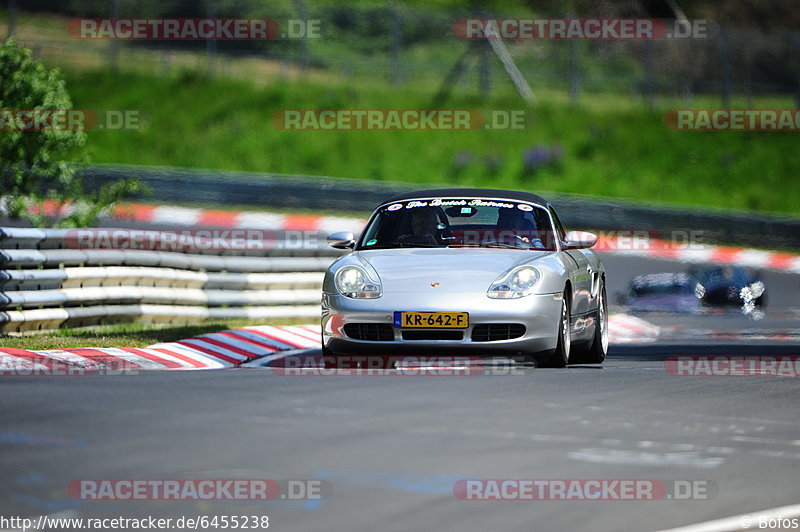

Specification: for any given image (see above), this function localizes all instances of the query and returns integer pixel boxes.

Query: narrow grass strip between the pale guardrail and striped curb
[0,319,310,350]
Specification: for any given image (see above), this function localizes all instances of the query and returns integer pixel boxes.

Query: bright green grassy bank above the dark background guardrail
[66,71,800,214]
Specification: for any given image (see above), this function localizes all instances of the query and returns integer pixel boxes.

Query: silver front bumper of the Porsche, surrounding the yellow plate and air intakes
[322,292,562,356]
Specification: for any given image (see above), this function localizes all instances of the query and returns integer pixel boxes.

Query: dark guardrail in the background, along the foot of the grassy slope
[82,165,800,249]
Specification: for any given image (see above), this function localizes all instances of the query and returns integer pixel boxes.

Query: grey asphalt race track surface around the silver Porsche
[0,251,800,531]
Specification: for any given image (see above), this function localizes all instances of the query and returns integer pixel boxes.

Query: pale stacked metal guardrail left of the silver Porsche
[0,228,341,333]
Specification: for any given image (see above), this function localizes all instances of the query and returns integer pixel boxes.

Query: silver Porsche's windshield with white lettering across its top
[358,198,555,251]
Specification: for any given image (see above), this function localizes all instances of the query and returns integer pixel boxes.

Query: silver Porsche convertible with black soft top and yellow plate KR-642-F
[322,189,608,367]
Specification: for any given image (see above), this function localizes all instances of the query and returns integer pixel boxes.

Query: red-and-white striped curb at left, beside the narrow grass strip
[0,325,320,375]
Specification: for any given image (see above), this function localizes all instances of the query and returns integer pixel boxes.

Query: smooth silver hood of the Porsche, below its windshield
[357,248,553,293]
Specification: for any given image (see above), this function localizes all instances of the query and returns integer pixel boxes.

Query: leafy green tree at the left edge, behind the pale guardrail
[0,39,141,227]
